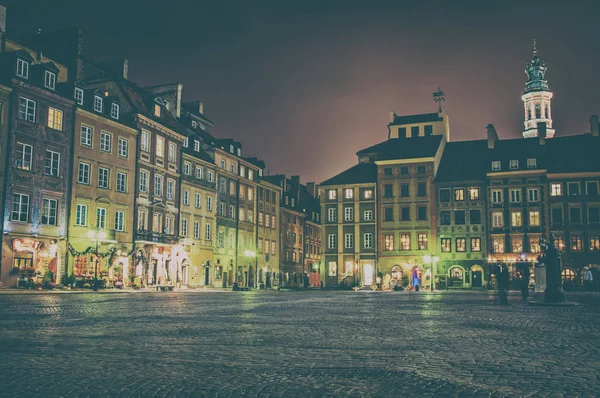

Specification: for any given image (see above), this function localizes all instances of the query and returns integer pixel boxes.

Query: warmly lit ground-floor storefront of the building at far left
[0,233,67,288]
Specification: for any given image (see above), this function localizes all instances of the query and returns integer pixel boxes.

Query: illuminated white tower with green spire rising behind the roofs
[521,40,554,138]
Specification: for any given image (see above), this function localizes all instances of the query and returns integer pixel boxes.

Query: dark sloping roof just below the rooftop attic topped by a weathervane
[356,135,443,160]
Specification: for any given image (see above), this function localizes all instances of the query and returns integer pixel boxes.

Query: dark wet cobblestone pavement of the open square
[0,291,600,397]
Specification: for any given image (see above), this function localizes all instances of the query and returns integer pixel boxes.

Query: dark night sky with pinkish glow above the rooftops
[0,0,600,182]
